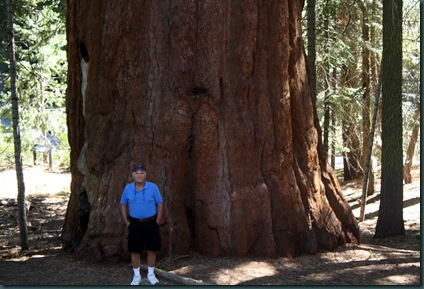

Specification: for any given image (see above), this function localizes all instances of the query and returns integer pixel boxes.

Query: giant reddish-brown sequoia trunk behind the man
[63,0,359,260]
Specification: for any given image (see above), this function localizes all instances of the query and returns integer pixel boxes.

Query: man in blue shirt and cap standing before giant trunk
[120,165,163,285]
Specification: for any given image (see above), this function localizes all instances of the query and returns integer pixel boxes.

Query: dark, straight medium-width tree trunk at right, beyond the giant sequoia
[374,0,405,238]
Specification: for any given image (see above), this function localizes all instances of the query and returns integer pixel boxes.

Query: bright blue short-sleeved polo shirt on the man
[120,181,163,219]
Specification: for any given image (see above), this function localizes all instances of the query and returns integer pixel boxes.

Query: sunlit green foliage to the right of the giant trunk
[303,0,420,164]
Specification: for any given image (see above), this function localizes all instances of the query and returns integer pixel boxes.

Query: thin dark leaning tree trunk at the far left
[6,0,28,250]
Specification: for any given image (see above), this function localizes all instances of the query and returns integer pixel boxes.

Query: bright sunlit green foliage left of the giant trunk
[0,0,69,166]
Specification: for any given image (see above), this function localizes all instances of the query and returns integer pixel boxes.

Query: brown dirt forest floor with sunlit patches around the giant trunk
[0,166,421,285]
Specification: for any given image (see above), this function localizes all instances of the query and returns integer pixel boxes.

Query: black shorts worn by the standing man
[128,218,161,253]
